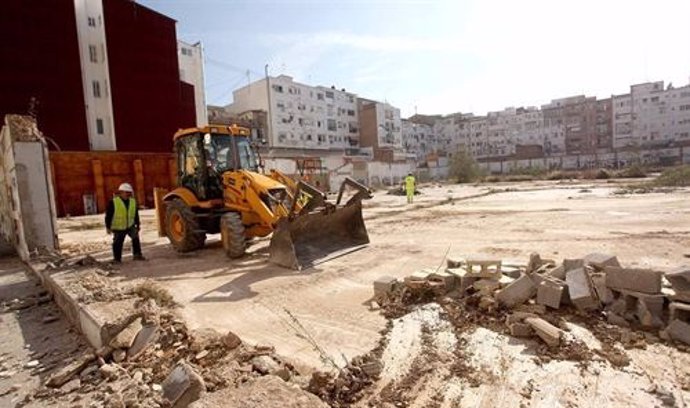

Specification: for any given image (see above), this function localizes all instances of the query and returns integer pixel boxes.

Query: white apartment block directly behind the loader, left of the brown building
[227,75,360,150]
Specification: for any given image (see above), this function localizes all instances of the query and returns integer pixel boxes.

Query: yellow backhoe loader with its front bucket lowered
[155,125,371,269]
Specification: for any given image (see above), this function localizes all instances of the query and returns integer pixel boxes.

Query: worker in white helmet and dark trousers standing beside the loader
[105,183,146,263]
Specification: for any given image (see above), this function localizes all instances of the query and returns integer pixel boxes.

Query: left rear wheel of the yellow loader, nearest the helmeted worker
[165,198,206,252]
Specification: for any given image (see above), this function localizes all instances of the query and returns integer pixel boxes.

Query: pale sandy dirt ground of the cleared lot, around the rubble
[60,182,690,406]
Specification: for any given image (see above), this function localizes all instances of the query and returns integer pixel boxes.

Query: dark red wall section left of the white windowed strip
[0,0,89,150]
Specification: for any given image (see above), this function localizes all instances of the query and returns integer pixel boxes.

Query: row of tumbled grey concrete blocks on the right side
[374,253,690,348]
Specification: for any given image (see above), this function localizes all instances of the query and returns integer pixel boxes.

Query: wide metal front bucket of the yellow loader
[269,201,369,270]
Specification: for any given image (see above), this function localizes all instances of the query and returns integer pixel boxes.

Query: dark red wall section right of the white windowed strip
[103,0,196,152]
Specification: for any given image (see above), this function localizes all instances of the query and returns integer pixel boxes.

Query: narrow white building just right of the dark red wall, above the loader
[177,40,208,126]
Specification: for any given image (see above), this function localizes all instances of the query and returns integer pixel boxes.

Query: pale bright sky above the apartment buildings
[139,0,690,117]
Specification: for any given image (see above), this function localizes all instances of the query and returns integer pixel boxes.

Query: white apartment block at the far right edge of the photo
[613,81,690,148]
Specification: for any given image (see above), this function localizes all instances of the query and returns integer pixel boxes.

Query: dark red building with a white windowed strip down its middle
[0,0,196,152]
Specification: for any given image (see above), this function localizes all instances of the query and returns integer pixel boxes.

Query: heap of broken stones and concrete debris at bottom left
[31,288,308,408]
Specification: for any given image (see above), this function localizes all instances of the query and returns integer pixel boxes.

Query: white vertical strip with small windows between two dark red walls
[74,0,117,150]
